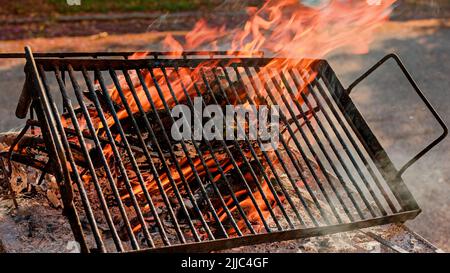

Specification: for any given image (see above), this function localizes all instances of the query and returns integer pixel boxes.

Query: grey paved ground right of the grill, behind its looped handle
[330,21,450,251]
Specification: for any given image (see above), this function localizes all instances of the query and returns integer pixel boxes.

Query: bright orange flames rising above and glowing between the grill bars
[57,0,395,238]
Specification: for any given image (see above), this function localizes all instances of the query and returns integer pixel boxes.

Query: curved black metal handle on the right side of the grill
[347,53,448,176]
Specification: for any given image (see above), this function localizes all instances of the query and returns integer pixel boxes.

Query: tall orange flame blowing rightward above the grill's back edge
[164,0,395,59]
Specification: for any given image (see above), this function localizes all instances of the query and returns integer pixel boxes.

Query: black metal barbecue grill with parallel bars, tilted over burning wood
[1,48,448,252]
